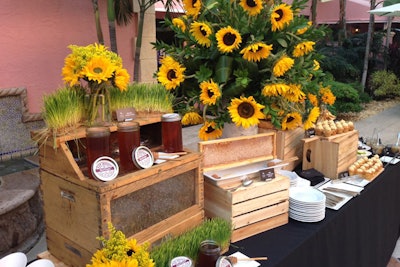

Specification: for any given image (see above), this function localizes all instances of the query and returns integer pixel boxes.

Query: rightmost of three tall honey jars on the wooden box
[161,113,183,153]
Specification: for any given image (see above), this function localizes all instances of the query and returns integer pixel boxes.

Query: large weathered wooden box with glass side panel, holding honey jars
[35,116,204,267]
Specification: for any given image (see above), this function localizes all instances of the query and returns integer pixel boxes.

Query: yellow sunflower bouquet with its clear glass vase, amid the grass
[62,44,130,124]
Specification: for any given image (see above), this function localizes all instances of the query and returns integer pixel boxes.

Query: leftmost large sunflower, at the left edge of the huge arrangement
[157,56,186,90]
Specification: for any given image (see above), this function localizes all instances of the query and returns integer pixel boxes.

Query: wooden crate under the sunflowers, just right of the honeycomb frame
[258,121,304,171]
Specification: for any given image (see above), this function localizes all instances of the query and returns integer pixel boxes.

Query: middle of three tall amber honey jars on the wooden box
[117,121,140,172]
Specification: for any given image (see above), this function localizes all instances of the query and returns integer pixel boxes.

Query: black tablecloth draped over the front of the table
[226,164,400,267]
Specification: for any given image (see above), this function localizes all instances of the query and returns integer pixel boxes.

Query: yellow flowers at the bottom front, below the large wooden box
[86,223,155,267]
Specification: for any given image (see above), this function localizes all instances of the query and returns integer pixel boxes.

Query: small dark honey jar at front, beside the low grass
[196,240,221,267]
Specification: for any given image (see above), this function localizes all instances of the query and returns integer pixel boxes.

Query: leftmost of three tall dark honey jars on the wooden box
[86,127,110,179]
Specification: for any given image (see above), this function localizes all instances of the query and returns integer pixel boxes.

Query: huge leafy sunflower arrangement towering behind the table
[154,0,332,140]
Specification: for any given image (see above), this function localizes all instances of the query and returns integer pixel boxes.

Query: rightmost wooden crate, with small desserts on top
[303,130,358,179]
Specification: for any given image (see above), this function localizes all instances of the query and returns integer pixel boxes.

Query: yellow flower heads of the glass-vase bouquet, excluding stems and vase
[62,44,130,90]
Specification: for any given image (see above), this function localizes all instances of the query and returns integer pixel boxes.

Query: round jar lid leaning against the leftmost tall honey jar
[92,156,119,182]
